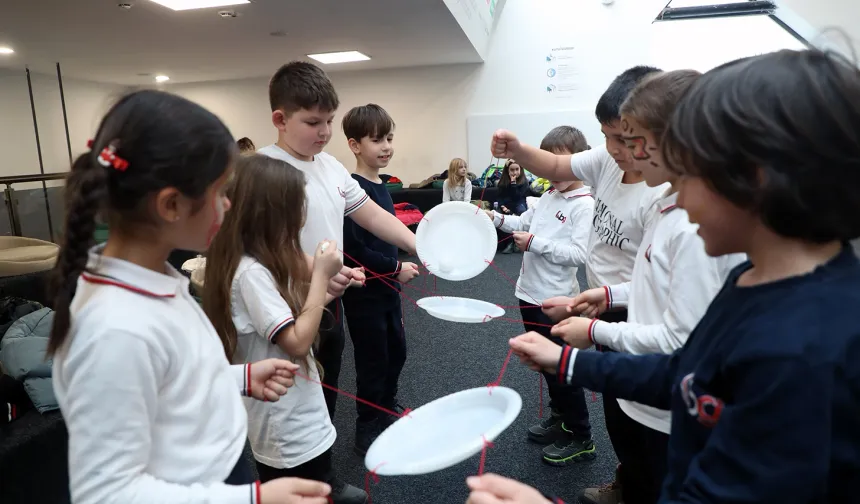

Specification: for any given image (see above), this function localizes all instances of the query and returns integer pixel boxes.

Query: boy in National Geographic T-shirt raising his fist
[493,66,667,488]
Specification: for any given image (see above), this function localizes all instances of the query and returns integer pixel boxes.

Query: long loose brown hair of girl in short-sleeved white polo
[203,154,310,361]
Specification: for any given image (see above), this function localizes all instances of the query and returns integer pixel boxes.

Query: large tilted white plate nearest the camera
[364,387,523,476]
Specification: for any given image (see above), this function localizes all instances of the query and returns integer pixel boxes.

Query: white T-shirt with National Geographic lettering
[570,146,669,289]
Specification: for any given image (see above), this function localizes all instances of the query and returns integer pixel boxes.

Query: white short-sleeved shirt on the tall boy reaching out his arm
[257,144,367,252]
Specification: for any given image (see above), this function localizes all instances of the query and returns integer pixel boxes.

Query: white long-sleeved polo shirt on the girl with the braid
[53,249,258,504]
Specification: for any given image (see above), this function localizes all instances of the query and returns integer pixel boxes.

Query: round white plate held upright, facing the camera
[415,201,498,281]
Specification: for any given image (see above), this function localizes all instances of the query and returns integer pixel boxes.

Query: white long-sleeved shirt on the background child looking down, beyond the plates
[493,187,594,305]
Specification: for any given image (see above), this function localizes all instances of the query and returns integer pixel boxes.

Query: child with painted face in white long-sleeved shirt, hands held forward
[555,70,745,504]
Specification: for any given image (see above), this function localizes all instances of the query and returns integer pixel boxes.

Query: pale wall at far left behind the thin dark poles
[0,70,122,180]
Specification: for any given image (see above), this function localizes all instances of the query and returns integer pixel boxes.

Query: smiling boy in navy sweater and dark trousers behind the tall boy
[342,103,418,455]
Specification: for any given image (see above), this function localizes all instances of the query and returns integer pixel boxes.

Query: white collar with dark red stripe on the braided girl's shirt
[81,245,187,298]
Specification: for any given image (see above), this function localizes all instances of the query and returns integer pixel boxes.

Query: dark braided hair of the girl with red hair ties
[47,90,236,356]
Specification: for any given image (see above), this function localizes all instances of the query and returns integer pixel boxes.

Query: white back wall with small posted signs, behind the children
[169,0,802,182]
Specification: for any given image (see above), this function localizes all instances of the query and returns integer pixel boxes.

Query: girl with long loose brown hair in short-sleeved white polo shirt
[203,155,367,504]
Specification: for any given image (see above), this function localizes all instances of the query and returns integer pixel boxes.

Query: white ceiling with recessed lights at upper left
[0,0,481,85]
